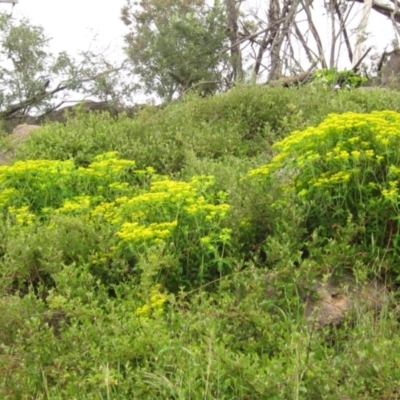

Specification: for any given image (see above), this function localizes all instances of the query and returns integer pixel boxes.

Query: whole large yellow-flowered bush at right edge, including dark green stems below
[249,111,400,270]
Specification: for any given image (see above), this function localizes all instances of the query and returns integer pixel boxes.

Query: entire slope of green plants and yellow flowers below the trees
[0,86,400,400]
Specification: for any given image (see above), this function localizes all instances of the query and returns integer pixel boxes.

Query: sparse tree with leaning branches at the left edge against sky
[0,13,130,119]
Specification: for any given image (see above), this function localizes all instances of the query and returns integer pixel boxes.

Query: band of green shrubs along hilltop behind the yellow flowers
[16,85,400,176]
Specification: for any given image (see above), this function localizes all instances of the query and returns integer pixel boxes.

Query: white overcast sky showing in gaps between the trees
[0,0,393,70]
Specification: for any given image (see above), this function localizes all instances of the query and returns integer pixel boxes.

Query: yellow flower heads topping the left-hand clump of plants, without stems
[0,152,230,258]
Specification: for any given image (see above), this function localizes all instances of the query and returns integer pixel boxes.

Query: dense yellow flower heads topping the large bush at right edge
[249,111,400,198]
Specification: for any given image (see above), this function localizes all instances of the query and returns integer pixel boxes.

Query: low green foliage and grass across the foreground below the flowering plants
[0,260,400,400]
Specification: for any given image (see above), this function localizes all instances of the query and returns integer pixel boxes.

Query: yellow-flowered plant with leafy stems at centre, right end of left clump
[108,176,231,290]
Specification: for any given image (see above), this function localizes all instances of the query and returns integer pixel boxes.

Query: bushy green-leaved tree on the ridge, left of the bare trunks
[122,0,231,100]
